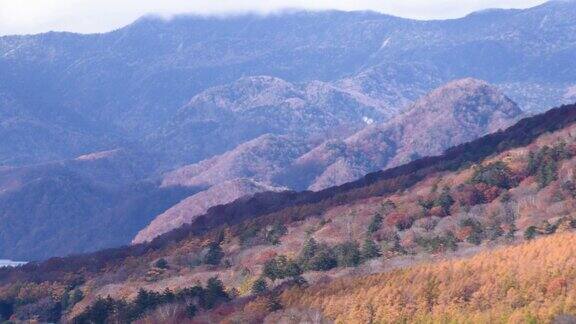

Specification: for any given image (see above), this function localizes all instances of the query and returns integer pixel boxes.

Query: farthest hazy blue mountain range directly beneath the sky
[0,1,576,164]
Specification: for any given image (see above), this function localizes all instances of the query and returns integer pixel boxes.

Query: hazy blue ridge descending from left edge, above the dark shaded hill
[0,90,117,165]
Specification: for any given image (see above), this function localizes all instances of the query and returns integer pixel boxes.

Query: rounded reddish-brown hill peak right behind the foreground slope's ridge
[281,79,522,190]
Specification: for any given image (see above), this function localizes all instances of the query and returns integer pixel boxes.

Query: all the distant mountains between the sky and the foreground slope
[0,1,576,260]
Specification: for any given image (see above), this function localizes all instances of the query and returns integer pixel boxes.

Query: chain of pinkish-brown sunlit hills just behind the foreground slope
[134,78,523,243]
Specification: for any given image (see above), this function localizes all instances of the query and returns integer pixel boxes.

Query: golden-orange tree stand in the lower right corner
[282,233,576,323]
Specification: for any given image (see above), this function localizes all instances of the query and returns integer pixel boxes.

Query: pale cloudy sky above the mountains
[0,0,545,35]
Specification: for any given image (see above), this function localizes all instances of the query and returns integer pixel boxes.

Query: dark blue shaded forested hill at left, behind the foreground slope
[0,150,197,260]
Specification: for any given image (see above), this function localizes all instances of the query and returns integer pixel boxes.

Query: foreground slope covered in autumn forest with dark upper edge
[0,101,576,323]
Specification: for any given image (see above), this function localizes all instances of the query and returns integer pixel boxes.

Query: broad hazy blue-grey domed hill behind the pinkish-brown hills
[149,76,395,162]
